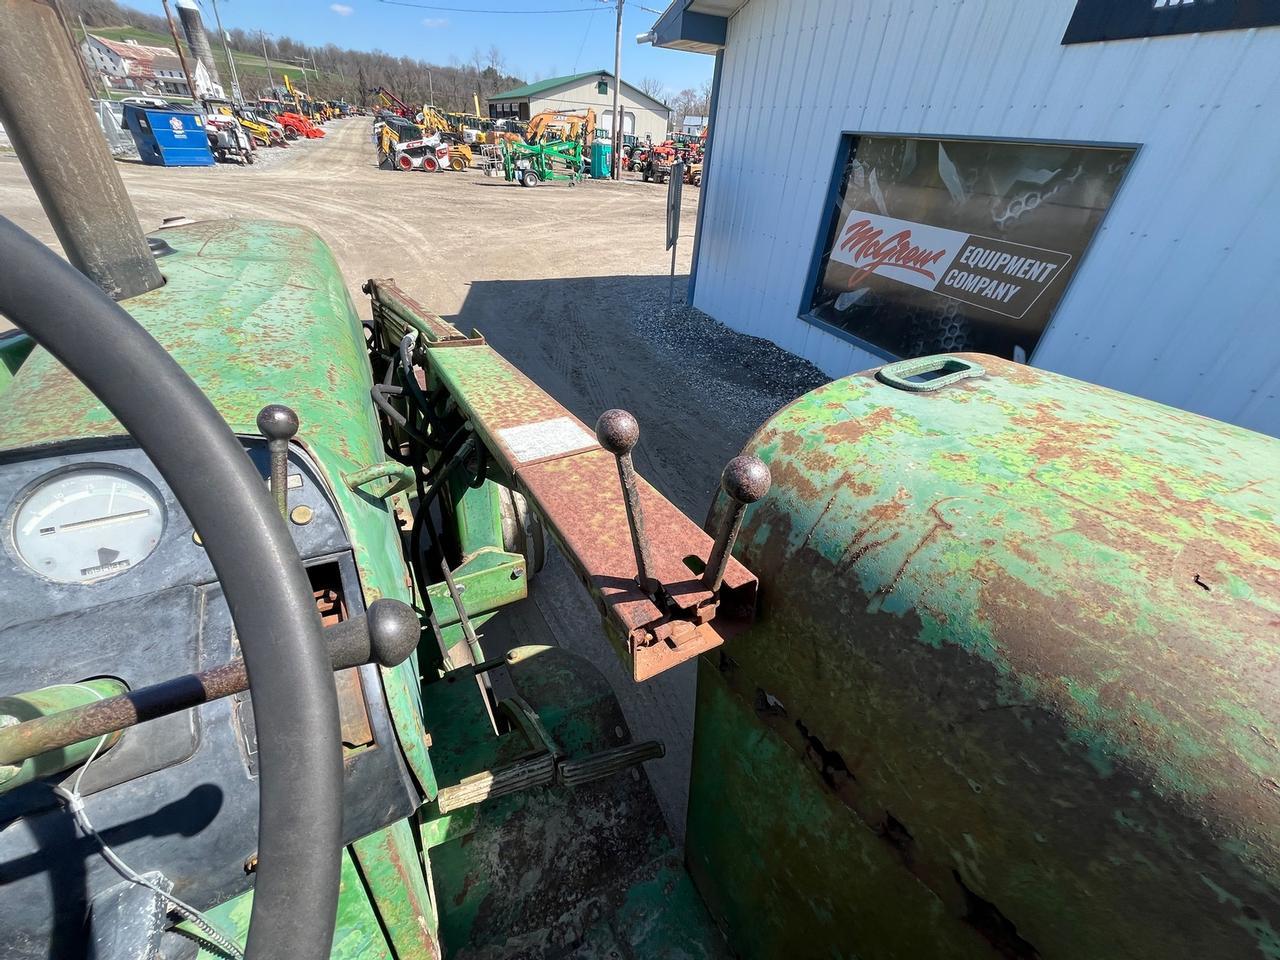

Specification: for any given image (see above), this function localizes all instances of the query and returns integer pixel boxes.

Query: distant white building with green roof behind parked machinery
[489,70,671,143]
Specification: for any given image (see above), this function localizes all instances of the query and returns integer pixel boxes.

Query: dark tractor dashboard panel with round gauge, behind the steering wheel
[0,438,417,956]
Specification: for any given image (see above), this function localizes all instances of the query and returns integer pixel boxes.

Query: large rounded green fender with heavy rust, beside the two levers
[687,357,1280,960]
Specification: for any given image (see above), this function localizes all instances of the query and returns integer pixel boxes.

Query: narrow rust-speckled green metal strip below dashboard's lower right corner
[351,820,440,960]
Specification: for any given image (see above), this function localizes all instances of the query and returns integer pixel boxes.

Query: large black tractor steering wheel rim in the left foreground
[0,216,343,960]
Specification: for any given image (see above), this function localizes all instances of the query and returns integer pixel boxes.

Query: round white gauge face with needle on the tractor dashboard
[13,466,164,584]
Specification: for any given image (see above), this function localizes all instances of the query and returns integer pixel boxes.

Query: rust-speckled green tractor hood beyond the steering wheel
[0,220,374,455]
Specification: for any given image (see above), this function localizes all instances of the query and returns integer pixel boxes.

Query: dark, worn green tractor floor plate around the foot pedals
[421,646,728,960]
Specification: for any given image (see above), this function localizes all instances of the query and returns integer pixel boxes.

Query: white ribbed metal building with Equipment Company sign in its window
[646,0,1280,435]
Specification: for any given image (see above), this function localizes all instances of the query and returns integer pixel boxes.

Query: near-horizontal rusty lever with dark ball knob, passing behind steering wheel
[0,598,422,765]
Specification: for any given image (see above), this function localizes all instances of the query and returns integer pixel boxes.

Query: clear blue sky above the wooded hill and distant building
[204,0,712,92]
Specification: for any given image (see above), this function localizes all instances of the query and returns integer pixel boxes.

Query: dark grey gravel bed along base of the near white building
[634,302,831,426]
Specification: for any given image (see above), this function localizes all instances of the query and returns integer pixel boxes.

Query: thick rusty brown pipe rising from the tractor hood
[0,0,164,300]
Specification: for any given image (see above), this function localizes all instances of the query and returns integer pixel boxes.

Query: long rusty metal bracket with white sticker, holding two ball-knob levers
[370,280,756,682]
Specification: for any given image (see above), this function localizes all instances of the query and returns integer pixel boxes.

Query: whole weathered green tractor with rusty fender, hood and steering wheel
[0,0,1280,960]
